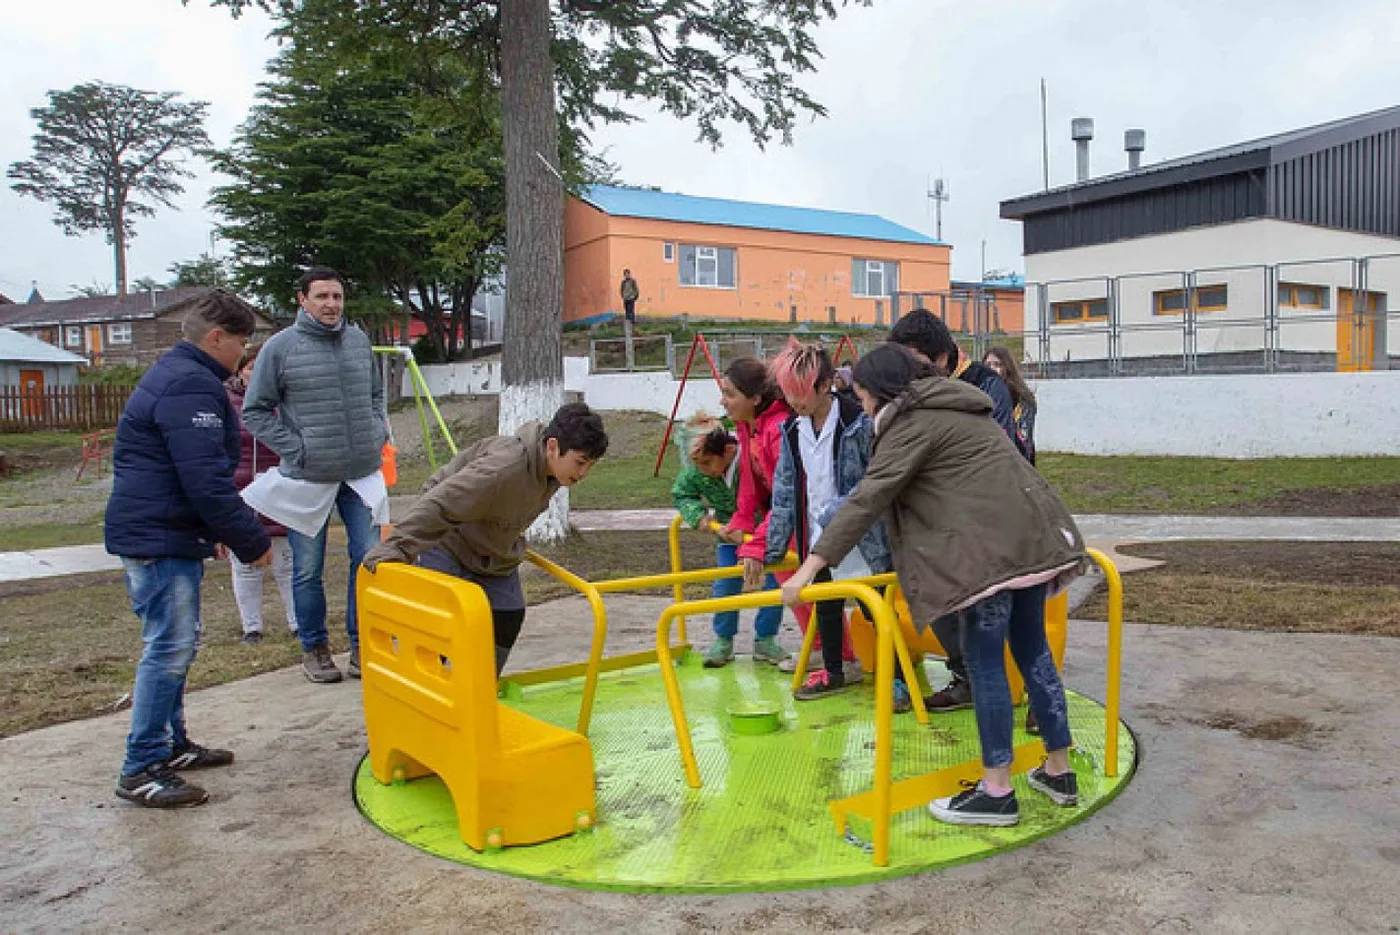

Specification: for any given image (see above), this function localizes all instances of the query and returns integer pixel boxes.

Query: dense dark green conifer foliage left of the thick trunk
[213,11,505,358]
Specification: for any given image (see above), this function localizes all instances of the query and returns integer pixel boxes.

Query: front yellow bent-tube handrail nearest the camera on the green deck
[657,581,897,866]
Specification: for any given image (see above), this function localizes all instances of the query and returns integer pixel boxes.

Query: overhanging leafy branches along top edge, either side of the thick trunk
[197,0,871,146]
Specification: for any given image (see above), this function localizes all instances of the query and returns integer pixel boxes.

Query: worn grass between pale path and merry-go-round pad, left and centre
[0,528,714,736]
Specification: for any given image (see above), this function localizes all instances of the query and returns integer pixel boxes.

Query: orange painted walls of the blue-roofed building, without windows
[564,200,952,325]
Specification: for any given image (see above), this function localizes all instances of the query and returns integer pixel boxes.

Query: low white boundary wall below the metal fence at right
[1035,371,1400,458]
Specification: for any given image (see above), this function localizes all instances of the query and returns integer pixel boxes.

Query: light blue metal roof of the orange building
[580,185,945,246]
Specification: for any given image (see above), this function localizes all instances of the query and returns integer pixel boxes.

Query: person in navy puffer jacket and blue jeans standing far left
[104,290,272,808]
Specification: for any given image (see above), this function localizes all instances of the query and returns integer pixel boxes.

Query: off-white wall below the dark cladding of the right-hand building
[1026,218,1400,360]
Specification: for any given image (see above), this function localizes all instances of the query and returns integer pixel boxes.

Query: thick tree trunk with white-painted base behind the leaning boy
[498,0,568,542]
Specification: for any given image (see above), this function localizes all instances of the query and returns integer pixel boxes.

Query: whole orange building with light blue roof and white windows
[564,185,952,325]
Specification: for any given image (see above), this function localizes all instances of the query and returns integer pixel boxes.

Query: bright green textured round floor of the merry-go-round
[354,654,1137,893]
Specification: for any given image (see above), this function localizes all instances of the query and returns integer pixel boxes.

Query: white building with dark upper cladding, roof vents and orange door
[1001,106,1400,375]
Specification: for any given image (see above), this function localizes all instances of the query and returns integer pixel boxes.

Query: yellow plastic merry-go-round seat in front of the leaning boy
[356,563,596,851]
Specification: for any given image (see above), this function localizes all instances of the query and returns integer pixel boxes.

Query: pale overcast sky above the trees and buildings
[0,0,1400,301]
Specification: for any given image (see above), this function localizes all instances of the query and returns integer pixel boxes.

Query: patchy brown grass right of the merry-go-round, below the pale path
[1075,542,1400,637]
